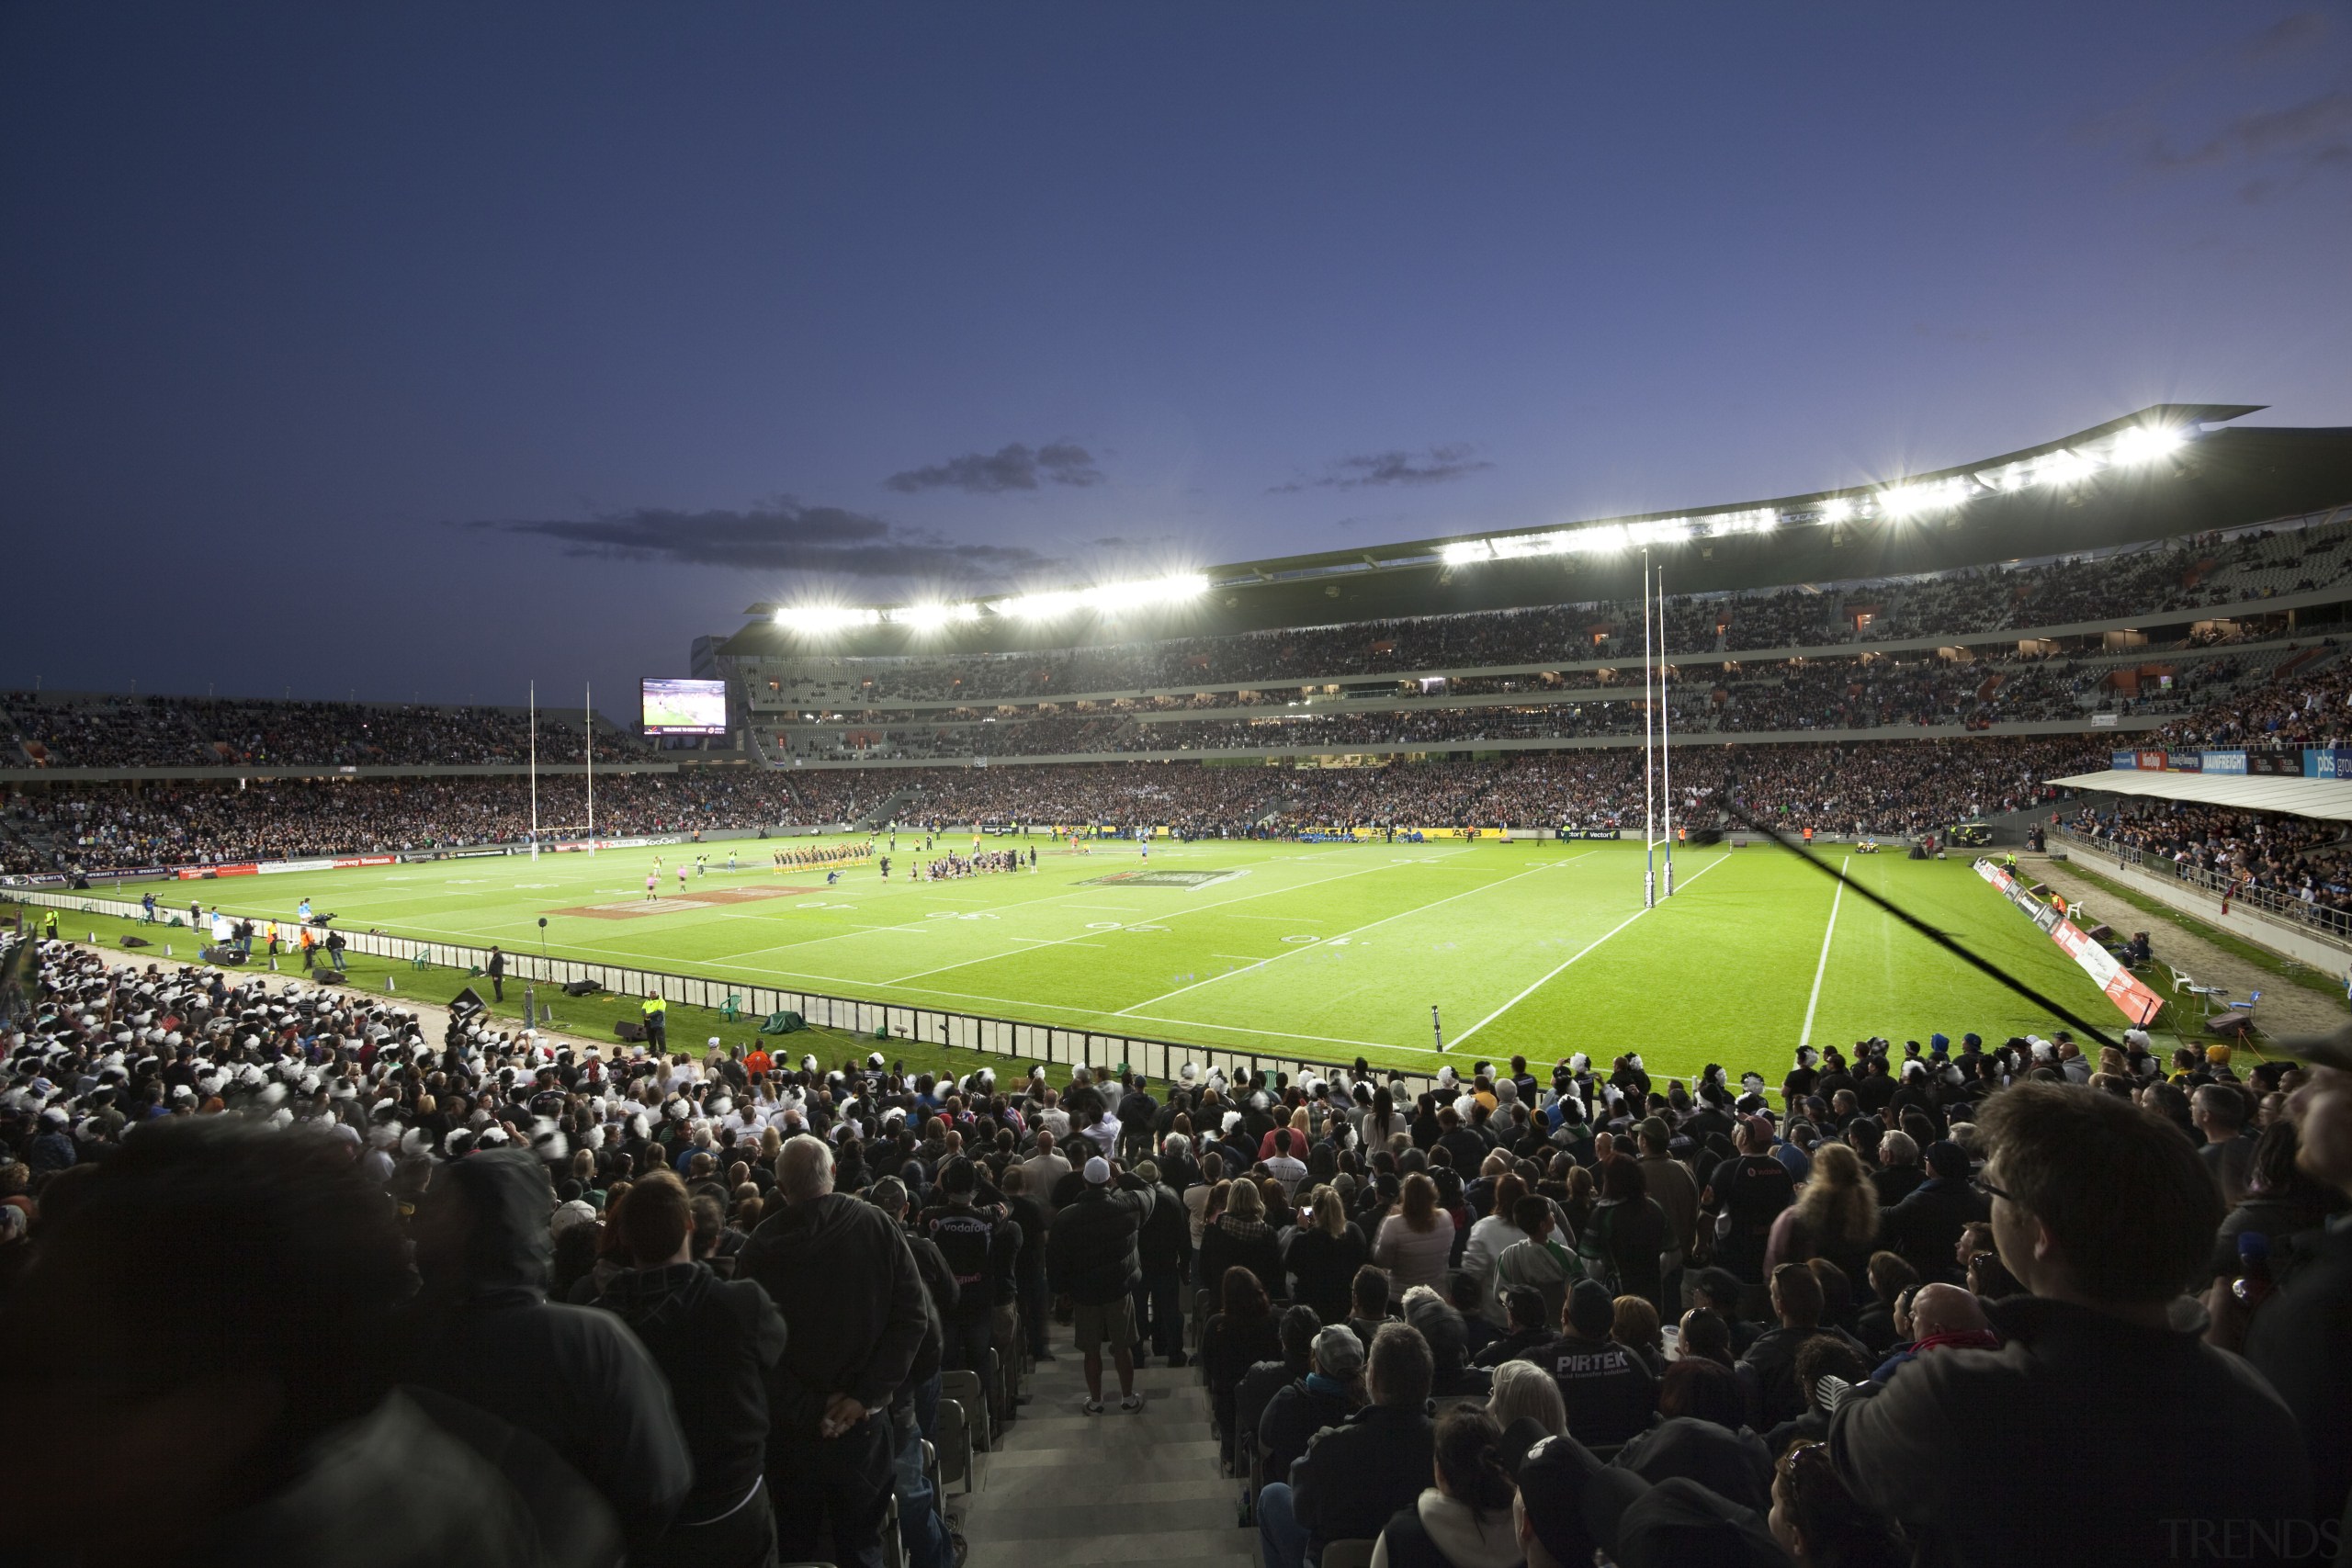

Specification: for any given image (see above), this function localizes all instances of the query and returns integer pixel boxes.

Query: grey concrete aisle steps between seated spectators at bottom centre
[948,1325,1259,1568]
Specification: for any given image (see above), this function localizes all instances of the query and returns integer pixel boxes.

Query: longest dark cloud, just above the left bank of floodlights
[468,496,1051,579]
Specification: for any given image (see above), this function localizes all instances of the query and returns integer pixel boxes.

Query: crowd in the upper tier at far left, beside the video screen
[0,691,639,769]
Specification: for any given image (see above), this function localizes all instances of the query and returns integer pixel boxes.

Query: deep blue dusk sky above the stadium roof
[0,0,2352,707]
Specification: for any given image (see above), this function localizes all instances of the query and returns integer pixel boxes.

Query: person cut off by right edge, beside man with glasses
[2246,1034,2352,1551]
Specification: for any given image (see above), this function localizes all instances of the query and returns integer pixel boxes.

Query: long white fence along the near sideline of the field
[0,888,1439,1096]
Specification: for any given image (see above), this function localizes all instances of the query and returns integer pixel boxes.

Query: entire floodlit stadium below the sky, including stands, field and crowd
[14,404,2352,1568]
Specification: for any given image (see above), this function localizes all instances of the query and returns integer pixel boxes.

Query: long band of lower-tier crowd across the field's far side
[0,736,2105,877]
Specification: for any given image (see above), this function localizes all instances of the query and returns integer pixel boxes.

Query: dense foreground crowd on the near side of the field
[0,921,2352,1568]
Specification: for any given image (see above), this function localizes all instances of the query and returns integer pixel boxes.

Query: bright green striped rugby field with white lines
[74,835,2121,1077]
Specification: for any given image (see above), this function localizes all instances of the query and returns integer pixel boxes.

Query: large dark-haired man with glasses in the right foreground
[1830,1084,2304,1565]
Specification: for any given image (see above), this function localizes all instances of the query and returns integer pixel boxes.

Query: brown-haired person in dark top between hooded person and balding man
[597,1170,786,1568]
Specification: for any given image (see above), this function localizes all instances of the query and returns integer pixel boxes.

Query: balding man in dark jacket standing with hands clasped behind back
[736,1134,929,1568]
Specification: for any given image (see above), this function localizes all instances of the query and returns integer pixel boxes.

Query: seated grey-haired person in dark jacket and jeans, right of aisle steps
[1259,1324,1437,1568]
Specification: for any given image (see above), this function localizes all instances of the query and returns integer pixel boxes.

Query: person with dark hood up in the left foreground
[409,1149,694,1556]
